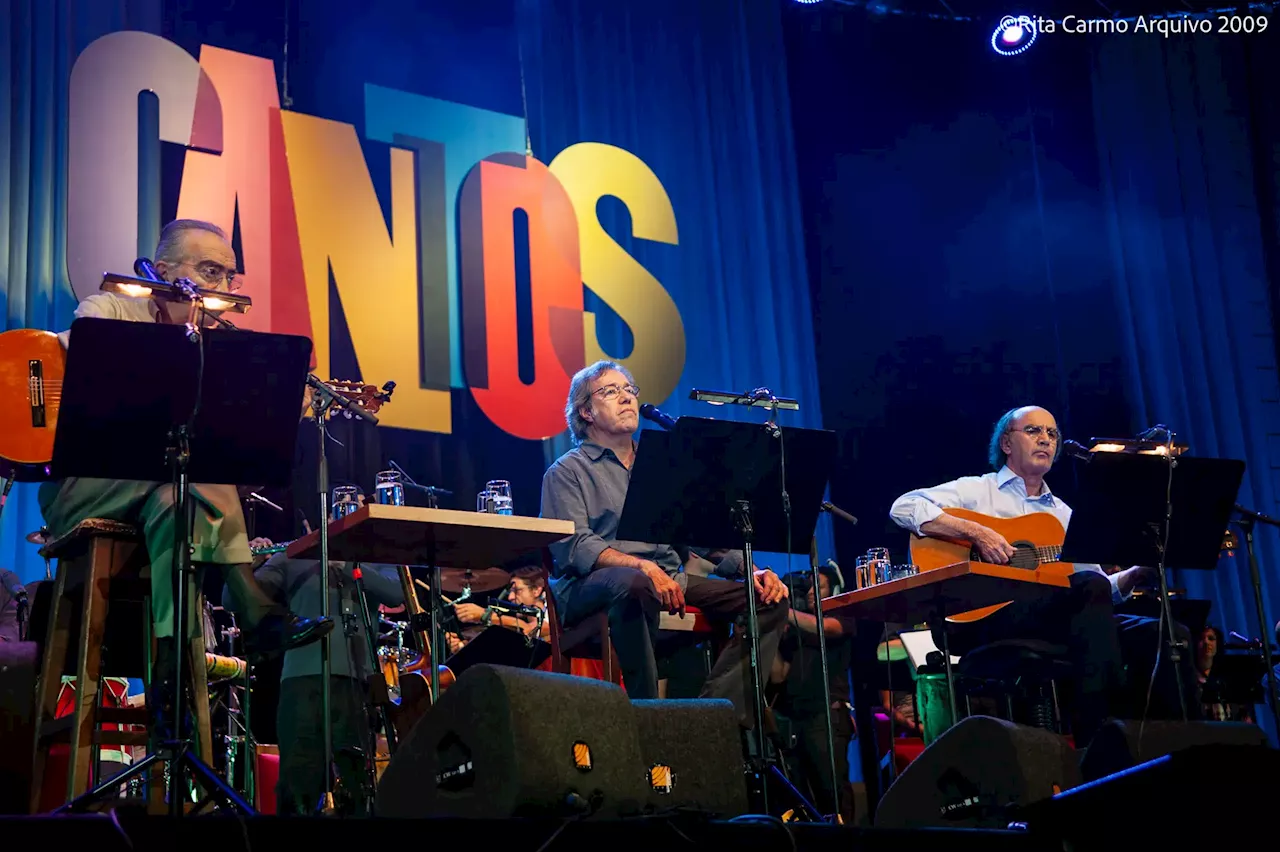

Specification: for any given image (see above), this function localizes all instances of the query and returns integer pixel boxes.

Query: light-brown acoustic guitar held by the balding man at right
[911,509,1074,622]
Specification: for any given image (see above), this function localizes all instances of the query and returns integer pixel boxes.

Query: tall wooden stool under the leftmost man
[31,518,212,812]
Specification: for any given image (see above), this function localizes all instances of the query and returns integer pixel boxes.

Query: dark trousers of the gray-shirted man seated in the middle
[557,568,788,728]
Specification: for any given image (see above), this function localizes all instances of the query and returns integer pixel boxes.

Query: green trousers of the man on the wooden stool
[38,477,251,638]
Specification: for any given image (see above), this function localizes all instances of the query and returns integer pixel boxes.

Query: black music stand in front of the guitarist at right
[1061,453,1244,719]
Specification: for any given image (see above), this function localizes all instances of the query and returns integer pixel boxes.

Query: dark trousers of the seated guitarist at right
[932,571,1125,748]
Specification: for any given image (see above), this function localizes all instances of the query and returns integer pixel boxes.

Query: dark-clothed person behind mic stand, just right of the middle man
[773,567,856,825]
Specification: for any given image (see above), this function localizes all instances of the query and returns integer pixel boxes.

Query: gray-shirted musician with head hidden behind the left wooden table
[228,500,404,816]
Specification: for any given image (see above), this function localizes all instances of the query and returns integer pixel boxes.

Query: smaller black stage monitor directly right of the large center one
[631,698,750,819]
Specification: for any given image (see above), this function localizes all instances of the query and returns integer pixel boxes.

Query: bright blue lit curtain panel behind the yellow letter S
[518,0,833,573]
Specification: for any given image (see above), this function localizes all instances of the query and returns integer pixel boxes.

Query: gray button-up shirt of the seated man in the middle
[541,441,742,586]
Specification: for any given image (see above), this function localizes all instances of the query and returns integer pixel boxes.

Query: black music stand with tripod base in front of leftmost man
[51,319,311,816]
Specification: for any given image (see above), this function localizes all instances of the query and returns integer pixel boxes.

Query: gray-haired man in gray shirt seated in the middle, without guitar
[541,361,787,728]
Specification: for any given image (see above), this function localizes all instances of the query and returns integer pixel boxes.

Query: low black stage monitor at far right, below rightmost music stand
[1080,719,1267,782]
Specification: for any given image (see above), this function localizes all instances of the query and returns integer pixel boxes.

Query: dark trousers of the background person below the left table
[275,674,372,816]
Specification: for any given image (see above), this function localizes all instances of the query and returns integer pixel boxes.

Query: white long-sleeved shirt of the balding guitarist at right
[888,464,1129,604]
